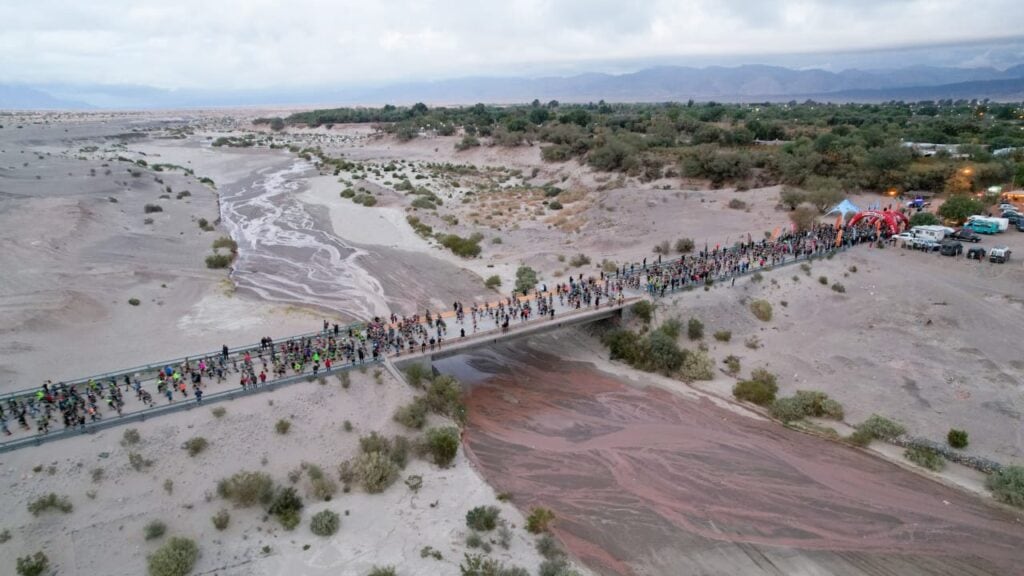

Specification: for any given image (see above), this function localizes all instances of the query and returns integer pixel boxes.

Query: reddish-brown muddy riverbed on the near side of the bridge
[446,346,1024,576]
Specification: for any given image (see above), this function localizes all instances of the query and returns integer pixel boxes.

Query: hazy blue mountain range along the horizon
[0,65,1024,110]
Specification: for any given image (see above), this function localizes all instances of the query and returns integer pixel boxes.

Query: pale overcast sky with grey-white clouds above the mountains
[0,0,1024,89]
